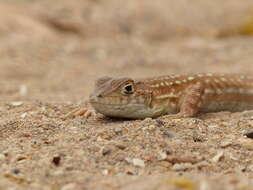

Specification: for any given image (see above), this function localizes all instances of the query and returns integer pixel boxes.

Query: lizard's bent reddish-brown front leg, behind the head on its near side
[166,82,204,119]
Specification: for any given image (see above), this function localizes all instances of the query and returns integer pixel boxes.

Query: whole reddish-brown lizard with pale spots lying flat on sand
[64,73,253,119]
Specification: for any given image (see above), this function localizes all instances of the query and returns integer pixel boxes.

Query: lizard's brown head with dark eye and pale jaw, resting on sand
[90,77,151,118]
